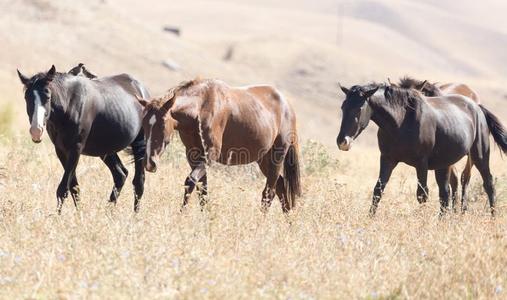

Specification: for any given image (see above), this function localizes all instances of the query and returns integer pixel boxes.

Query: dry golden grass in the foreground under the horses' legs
[0,137,507,299]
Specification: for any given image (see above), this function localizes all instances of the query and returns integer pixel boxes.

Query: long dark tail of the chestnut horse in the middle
[283,141,301,209]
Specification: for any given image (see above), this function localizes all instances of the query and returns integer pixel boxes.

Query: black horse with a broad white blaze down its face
[17,65,149,214]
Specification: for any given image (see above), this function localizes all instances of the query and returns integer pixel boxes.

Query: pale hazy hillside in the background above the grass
[0,0,507,145]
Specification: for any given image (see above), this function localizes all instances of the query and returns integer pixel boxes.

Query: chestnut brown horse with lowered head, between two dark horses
[138,79,301,213]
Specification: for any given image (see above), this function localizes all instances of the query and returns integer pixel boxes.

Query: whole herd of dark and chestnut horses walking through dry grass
[18,64,507,215]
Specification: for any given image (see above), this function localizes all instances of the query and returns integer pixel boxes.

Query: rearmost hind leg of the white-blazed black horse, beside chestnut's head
[131,130,146,212]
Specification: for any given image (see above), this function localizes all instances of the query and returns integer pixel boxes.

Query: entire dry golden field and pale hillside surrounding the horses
[0,0,507,299]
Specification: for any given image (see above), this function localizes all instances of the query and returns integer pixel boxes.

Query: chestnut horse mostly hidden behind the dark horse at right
[391,76,481,211]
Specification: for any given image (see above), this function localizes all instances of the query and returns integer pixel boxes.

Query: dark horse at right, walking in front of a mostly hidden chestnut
[337,83,507,216]
